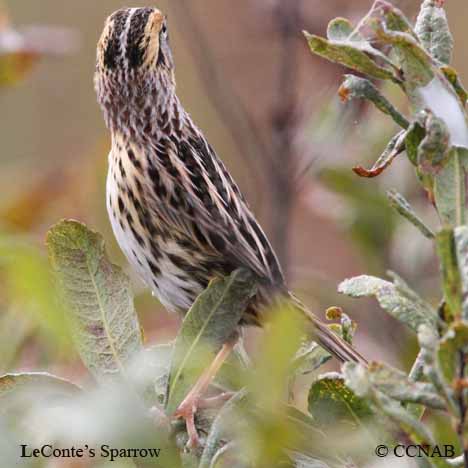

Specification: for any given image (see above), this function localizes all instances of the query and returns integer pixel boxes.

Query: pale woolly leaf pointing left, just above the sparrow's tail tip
[338,275,438,332]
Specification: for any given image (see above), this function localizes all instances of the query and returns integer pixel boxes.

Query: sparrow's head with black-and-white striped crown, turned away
[94,8,175,133]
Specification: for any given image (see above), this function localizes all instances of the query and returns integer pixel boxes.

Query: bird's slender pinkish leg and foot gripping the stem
[174,340,236,447]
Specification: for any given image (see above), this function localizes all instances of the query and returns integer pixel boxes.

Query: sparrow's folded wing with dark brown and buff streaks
[143,134,284,285]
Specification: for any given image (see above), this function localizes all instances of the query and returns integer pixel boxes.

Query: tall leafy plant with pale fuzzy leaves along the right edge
[306,0,468,466]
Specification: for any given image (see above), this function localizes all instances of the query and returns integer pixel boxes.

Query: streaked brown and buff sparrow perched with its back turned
[94,7,367,444]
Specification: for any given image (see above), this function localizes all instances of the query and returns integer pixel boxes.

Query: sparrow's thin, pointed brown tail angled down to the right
[289,293,369,367]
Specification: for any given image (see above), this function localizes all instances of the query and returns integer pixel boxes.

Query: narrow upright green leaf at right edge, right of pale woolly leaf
[436,228,462,318]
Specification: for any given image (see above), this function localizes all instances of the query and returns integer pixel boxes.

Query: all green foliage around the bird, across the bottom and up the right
[0,0,468,468]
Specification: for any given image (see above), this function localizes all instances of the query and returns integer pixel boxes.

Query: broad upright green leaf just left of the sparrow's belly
[47,221,142,379]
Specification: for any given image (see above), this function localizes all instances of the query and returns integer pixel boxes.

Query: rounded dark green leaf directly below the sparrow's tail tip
[308,373,373,428]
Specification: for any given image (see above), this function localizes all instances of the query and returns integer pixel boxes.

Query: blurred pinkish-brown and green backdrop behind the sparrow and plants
[0,0,468,394]
